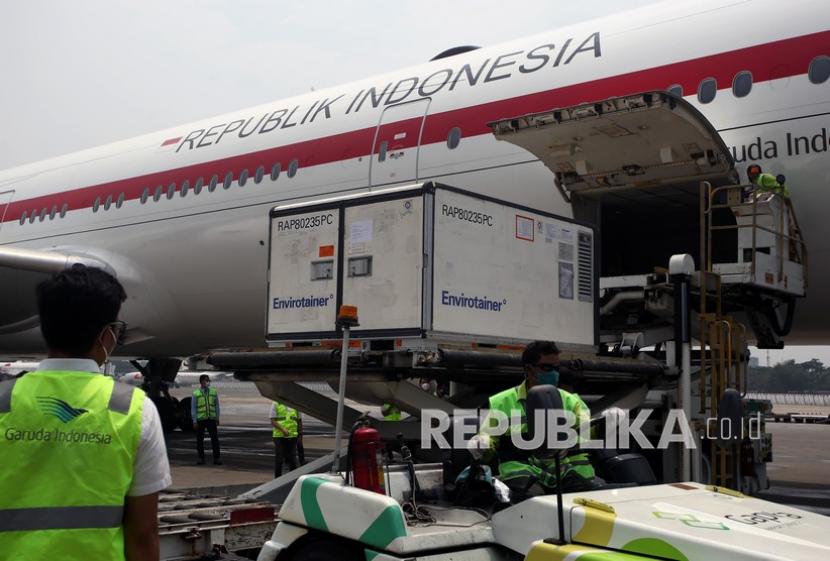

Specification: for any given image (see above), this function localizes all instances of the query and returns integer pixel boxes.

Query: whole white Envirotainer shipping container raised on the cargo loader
[267,183,596,347]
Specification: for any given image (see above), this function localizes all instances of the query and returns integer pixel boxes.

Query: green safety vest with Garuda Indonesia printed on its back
[0,371,146,561]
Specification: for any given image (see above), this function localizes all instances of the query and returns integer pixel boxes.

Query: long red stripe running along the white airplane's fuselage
[4,31,830,222]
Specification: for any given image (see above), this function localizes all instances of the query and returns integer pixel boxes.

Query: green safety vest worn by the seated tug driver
[485,382,595,488]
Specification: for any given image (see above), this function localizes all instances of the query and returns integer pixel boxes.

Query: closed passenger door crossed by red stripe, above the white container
[369,99,430,187]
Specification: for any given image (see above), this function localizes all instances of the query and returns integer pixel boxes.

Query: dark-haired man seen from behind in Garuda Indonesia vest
[0,265,171,561]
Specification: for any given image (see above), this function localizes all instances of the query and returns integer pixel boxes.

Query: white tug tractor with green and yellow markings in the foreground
[258,386,830,561]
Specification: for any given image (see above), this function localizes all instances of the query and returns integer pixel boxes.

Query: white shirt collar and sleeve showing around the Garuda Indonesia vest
[37,358,173,497]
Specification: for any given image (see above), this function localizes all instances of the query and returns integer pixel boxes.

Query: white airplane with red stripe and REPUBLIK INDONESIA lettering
[0,0,830,369]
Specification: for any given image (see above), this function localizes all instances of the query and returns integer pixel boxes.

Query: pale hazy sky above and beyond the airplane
[0,0,830,364]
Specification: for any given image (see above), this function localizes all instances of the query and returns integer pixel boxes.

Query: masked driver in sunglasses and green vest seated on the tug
[477,341,601,501]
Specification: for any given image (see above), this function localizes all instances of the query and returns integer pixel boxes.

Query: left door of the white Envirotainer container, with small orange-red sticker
[267,209,340,336]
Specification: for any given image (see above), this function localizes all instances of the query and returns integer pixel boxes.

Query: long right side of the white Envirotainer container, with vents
[432,189,594,345]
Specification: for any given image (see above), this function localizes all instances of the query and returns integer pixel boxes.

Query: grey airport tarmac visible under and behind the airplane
[167,382,830,515]
